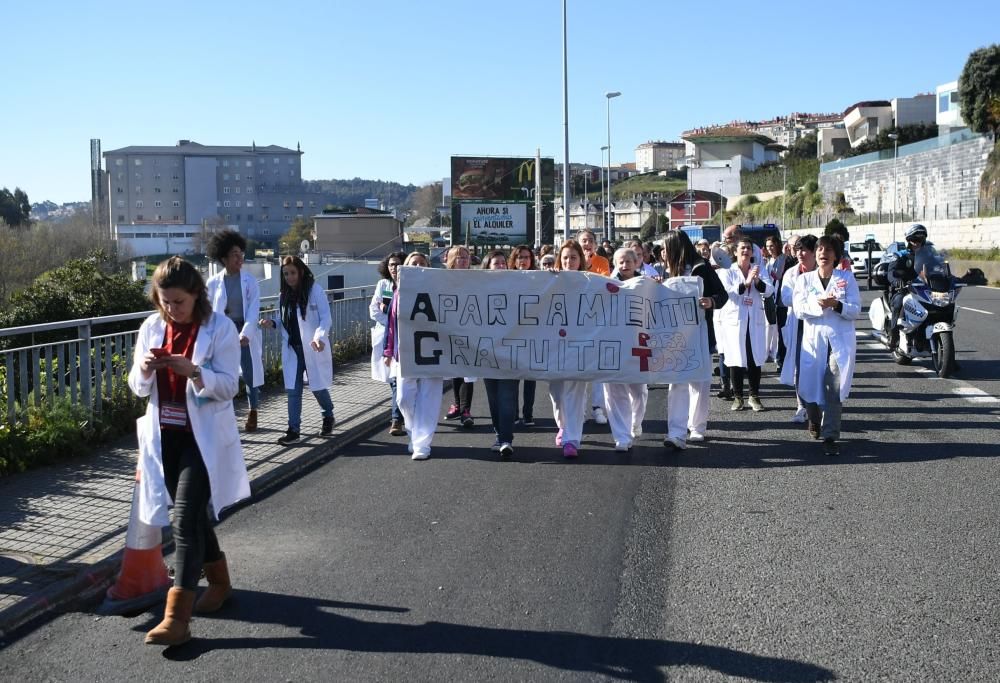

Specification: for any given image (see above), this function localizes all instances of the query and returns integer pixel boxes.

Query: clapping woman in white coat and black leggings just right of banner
[719,237,774,412]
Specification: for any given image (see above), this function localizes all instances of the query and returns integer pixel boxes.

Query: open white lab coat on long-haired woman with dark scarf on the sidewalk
[275,282,333,391]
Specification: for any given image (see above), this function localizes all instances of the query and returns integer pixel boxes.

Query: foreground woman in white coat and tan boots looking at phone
[128,256,250,645]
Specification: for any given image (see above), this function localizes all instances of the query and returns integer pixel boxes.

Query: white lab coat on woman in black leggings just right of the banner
[716,263,774,368]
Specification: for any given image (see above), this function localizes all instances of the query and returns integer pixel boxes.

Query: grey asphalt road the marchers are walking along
[0,288,1000,681]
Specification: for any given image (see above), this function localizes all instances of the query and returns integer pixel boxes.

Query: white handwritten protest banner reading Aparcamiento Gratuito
[398,267,712,384]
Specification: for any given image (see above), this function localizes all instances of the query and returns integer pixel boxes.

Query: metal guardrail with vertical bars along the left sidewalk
[0,285,375,425]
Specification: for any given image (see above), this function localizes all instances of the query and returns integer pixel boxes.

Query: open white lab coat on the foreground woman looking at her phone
[128,313,250,527]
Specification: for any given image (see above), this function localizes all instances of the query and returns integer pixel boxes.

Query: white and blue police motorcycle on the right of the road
[868,244,965,378]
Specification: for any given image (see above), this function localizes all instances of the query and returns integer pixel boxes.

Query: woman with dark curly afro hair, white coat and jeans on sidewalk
[206,230,264,432]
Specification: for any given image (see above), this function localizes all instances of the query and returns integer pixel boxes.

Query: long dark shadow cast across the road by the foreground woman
[158,591,836,681]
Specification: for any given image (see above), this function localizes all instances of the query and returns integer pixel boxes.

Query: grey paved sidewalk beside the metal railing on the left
[0,360,390,646]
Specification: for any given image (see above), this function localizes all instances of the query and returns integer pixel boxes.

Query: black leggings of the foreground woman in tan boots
[160,429,222,590]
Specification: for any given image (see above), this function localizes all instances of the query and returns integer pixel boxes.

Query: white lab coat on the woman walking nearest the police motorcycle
[792,269,861,405]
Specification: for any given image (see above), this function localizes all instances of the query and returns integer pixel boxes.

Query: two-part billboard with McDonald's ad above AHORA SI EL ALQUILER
[451,156,555,246]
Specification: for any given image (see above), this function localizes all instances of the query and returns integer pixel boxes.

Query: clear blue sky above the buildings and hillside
[0,0,1000,202]
